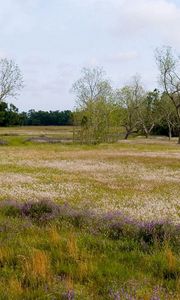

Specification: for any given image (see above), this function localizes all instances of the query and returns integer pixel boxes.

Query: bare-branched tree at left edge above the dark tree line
[0,58,23,101]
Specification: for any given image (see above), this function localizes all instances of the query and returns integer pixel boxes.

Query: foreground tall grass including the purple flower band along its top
[0,201,180,300]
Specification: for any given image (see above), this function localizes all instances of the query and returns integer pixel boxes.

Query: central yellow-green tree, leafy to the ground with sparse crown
[72,67,113,144]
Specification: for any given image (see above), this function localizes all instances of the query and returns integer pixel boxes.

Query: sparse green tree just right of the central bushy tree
[116,75,160,139]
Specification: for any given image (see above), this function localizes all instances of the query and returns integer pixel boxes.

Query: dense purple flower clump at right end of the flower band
[99,211,180,250]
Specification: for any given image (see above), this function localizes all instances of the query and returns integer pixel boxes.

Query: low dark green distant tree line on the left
[0,101,73,126]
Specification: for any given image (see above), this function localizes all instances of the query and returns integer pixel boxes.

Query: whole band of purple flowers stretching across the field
[0,200,180,246]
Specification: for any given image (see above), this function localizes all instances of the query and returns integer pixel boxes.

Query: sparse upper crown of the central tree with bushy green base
[72,67,112,108]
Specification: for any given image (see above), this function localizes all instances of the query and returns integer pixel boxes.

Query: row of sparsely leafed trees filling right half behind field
[72,47,180,144]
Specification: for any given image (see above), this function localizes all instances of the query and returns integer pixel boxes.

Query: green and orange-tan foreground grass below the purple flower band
[0,206,179,299]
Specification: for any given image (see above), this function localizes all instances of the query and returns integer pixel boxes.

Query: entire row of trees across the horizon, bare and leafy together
[0,47,180,144]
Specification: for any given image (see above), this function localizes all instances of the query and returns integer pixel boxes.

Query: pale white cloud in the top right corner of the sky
[114,0,180,44]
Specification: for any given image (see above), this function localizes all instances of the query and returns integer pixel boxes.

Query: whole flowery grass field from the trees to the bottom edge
[0,127,180,300]
